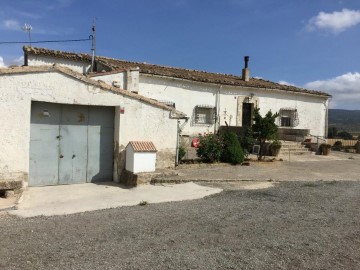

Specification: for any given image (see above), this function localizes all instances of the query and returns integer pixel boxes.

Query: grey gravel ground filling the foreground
[0,182,360,269]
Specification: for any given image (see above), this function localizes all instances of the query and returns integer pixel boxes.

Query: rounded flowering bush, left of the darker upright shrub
[196,133,224,163]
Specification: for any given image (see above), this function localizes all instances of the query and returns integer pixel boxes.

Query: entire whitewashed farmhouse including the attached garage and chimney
[0,46,331,193]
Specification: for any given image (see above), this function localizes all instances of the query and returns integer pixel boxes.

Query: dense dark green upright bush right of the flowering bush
[221,131,244,165]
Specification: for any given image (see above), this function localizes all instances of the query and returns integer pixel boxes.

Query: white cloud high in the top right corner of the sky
[306,9,360,33]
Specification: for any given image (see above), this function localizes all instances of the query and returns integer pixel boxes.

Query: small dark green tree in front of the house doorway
[252,108,279,160]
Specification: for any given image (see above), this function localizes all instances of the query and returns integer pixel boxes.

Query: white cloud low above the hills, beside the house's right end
[304,72,360,110]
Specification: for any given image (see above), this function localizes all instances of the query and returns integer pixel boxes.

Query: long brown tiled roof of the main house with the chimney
[24,46,331,97]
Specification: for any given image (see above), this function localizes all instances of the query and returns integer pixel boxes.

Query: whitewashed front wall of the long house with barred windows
[139,74,327,136]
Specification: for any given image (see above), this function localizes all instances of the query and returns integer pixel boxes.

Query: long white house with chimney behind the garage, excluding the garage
[24,47,331,140]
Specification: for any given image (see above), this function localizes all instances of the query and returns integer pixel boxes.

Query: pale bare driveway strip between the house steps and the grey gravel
[156,152,360,182]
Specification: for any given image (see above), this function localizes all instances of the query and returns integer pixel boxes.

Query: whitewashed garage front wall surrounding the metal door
[0,72,177,187]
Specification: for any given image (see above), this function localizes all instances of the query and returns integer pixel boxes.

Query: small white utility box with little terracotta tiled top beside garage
[125,141,157,173]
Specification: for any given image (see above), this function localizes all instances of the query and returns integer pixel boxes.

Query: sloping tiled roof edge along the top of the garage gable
[0,65,186,118]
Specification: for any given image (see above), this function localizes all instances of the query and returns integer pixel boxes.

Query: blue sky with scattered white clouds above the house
[0,0,360,109]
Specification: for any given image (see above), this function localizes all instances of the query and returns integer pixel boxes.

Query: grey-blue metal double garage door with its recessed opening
[29,102,115,186]
